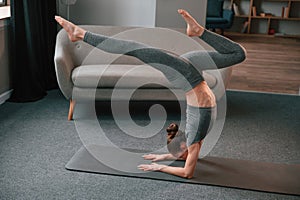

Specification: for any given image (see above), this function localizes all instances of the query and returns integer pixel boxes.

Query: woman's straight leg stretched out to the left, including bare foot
[56,17,204,92]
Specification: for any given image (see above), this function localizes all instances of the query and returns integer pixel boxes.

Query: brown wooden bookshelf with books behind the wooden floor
[227,0,300,37]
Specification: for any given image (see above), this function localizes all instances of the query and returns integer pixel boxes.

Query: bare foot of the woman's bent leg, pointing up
[178,9,204,36]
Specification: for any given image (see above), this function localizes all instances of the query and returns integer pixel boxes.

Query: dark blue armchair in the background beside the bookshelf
[206,0,234,35]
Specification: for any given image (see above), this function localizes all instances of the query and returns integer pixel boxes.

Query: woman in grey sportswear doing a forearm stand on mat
[55,9,245,178]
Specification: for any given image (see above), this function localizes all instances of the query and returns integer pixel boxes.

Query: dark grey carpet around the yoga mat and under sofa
[0,90,300,200]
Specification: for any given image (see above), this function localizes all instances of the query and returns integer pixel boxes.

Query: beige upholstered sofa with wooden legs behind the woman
[54,26,232,120]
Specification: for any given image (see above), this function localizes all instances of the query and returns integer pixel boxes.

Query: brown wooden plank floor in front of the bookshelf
[225,33,300,95]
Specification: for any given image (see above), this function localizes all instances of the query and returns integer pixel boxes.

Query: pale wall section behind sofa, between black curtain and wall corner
[59,0,156,27]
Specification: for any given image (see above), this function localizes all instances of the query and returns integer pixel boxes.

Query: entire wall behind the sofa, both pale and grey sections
[57,0,206,28]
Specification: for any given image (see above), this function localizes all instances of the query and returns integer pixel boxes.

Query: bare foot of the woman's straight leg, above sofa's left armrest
[55,16,86,42]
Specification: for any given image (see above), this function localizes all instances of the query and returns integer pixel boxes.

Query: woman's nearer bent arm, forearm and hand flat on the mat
[138,142,202,178]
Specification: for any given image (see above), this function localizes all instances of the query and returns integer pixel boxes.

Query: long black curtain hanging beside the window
[10,0,57,102]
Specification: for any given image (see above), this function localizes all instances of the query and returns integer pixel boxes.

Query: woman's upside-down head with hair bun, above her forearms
[167,123,187,158]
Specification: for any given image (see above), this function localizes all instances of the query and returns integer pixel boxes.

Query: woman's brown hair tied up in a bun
[166,123,186,156]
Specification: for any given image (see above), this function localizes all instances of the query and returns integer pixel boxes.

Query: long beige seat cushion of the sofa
[72,64,217,89]
